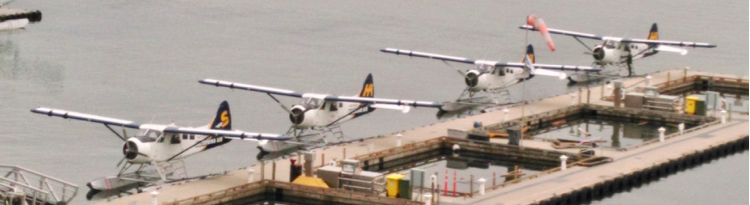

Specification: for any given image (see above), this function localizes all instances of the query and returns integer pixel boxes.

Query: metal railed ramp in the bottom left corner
[0,164,78,205]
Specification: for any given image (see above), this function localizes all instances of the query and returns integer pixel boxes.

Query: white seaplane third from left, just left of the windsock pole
[380,44,600,101]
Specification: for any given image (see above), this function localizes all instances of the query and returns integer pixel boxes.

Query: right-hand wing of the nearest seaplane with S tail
[164,127,292,140]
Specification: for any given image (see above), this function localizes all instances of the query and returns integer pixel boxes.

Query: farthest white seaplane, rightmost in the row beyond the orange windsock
[520,23,716,82]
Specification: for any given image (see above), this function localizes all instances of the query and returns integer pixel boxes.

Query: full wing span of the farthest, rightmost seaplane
[519,25,716,48]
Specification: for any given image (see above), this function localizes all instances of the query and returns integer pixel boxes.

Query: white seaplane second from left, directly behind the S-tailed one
[199,74,471,152]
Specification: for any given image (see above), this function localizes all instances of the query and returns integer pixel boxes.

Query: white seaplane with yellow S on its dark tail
[31,101,292,194]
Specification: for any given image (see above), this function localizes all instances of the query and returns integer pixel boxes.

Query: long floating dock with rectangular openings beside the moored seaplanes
[100,69,750,205]
